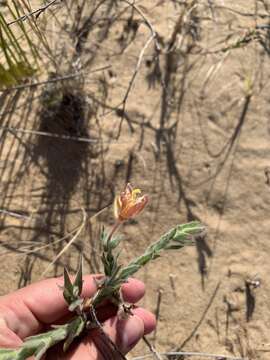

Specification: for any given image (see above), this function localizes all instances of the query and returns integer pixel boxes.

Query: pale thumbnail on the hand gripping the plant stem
[118,315,144,353]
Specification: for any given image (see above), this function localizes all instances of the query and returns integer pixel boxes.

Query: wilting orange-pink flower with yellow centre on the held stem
[114,184,148,221]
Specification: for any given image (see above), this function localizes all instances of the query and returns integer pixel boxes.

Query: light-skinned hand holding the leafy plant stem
[0,275,156,360]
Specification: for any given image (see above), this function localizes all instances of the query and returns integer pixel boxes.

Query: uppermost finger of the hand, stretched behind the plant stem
[0,275,144,338]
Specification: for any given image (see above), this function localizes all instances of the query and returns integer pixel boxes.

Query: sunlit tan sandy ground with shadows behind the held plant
[0,0,270,360]
